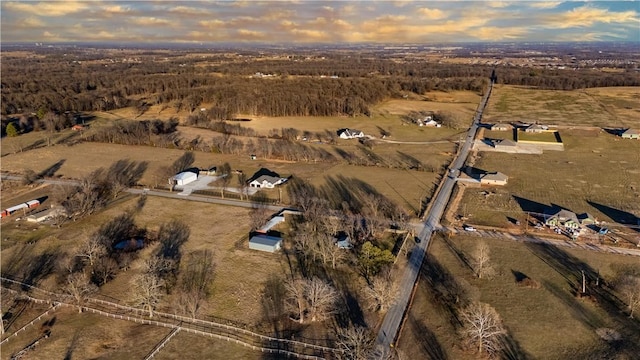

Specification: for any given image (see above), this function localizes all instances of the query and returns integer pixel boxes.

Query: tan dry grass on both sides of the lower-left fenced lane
[2,196,289,359]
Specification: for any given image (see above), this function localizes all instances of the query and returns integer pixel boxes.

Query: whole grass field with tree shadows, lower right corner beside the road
[399,237,640,359]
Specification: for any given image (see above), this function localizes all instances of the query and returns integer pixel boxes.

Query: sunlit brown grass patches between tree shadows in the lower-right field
[399,237,640,359]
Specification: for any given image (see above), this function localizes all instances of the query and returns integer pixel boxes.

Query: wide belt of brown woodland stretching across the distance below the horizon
[2,52,640,119]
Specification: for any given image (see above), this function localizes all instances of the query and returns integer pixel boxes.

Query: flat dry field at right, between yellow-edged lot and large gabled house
[458,131,640,226]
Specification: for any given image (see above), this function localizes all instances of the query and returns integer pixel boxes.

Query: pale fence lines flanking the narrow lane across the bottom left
[0,277,344,360]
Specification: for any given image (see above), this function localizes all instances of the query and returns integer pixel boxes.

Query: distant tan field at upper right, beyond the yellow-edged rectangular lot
[483,85,640,128]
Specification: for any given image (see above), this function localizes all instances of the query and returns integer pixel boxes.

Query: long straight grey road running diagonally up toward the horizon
[376,82,493,359]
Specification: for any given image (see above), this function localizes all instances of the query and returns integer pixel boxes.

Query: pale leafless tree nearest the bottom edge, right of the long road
[460,302,506,355]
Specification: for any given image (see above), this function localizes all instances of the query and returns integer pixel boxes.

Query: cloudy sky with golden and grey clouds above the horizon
[0,0,640,44]
